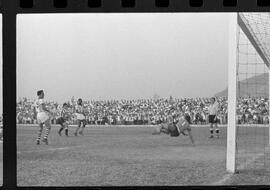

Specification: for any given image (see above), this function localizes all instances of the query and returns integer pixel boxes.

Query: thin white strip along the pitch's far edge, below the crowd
[17,124,269,128]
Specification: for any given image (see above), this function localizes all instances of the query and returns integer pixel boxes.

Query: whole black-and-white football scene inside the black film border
[15,12,270,187]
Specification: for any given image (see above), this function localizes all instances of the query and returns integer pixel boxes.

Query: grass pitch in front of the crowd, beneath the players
[17,126,270,186]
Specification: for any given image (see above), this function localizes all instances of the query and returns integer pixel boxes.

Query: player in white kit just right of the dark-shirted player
[74,98,86,136]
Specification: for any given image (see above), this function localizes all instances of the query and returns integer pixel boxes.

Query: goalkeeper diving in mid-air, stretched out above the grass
[152,113,194,145]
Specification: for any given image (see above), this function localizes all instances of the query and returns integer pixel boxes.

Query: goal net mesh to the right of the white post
[236,13,270,179]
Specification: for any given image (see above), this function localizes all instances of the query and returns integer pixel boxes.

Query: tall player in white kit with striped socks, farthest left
[34,90,51,145]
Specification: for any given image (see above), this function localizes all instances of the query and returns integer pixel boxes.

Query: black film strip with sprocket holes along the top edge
[0,0,270,14]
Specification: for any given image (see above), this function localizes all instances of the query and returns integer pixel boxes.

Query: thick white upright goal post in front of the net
[226,13,238,173]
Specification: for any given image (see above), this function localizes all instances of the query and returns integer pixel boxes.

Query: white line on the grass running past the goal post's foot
[211,147,270,186]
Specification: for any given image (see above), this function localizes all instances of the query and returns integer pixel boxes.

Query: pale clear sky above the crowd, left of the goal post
[17,13,229,102]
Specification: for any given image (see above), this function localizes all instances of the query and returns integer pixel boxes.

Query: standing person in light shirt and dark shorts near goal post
[208,97,219,138]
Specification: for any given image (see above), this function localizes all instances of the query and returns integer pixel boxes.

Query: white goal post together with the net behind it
[226,13,270,173]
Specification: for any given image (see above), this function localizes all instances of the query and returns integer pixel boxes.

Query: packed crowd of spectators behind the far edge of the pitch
[17,97,269,125]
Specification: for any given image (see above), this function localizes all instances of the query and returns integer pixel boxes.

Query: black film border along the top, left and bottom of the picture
[0,0,270,189]
